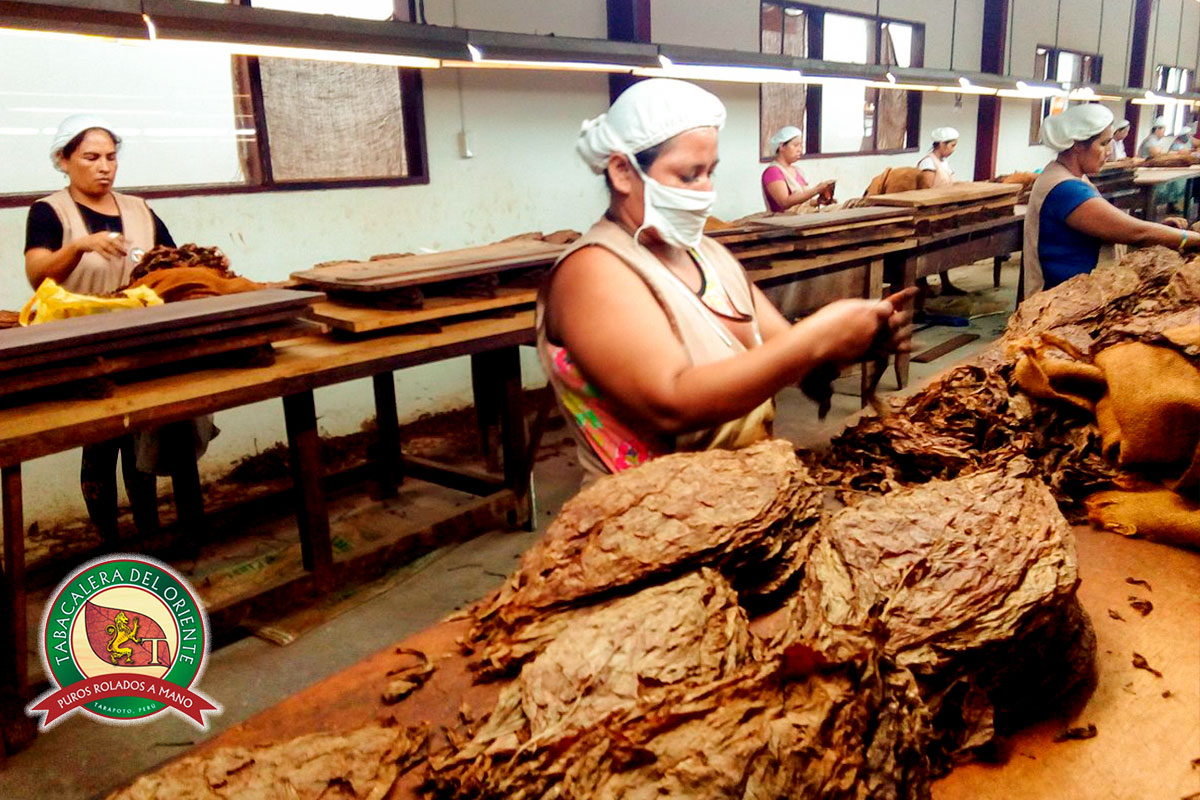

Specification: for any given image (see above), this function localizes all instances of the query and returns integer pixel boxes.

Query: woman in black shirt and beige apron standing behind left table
[25,114,216,543]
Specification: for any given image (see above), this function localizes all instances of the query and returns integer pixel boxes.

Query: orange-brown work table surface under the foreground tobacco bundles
[147,527,1200,800]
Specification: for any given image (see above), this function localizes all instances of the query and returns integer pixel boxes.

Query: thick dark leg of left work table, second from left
[283,391,334,590]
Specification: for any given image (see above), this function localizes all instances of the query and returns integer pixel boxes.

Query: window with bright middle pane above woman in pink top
[760,0,924,161]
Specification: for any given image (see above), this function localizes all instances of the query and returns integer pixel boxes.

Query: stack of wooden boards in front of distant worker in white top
[864,181,1021,236]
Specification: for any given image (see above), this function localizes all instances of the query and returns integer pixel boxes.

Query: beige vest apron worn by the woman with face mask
[536,218,775,481]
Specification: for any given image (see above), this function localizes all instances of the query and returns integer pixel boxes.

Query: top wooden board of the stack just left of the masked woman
[292,239,566,291]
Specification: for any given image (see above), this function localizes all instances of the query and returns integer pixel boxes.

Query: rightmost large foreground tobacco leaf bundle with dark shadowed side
[791,459,1094,766]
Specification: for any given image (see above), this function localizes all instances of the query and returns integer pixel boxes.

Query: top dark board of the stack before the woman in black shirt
[0,289,324,368]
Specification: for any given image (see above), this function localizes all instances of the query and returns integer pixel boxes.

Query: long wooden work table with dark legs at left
[0,311,533,734]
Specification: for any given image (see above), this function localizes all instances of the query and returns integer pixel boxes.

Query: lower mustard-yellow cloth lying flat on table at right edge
[1086,488,1200,549]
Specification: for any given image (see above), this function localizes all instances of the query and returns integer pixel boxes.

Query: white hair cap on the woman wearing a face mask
[575,78,725,175]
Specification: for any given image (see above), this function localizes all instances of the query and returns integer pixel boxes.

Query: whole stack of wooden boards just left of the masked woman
[292,239,566,333]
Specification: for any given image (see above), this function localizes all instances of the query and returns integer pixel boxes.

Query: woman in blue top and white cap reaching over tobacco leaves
[1021,103,1200,297]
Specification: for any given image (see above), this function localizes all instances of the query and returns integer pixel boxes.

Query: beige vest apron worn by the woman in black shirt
[42,190,155,295]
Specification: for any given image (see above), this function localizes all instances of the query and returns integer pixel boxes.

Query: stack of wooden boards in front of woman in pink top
[708,207,913,261]
